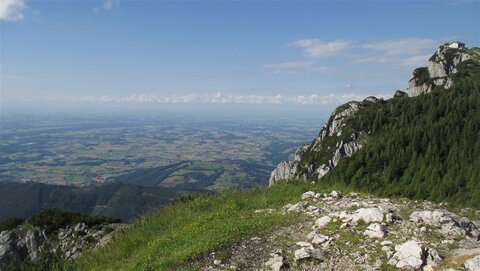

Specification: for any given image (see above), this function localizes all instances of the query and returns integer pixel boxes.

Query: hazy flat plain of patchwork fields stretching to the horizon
[0,111,322,190]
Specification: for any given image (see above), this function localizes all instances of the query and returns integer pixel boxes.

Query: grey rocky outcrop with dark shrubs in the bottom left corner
[0,223,124,271]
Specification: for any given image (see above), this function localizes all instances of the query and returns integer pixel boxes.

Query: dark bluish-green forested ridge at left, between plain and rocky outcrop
[0,183,191,223]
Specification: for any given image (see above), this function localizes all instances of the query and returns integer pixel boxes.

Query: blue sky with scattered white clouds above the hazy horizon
[0,0,480,110]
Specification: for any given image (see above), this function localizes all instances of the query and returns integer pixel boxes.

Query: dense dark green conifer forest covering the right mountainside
[322,60,480,207]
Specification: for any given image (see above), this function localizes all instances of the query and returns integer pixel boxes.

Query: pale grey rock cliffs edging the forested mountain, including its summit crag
[269,44,480,185]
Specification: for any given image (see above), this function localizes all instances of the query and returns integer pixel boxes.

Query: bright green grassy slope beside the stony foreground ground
[48,182,326,270]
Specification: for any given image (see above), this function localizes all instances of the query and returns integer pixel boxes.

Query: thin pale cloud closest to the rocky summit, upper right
[362,38,439,55]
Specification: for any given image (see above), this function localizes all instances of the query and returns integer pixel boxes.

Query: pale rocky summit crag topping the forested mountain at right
[407,44,479,97]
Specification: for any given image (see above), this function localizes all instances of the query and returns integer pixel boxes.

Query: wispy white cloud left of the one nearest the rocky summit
[288,39,352,57]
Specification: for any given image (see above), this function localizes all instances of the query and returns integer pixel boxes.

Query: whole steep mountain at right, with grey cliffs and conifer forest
[270,45,480,207]
